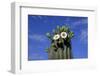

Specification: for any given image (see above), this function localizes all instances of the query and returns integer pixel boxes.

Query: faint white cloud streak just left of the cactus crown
[29,34,47,42]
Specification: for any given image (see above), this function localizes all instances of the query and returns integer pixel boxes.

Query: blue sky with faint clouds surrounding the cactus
[28,15,88,60]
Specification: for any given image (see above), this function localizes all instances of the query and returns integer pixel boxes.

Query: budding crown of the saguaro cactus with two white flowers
[46,26,74,41]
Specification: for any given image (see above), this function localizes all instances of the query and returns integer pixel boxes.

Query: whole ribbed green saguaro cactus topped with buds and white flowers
[46,26,74,59]
